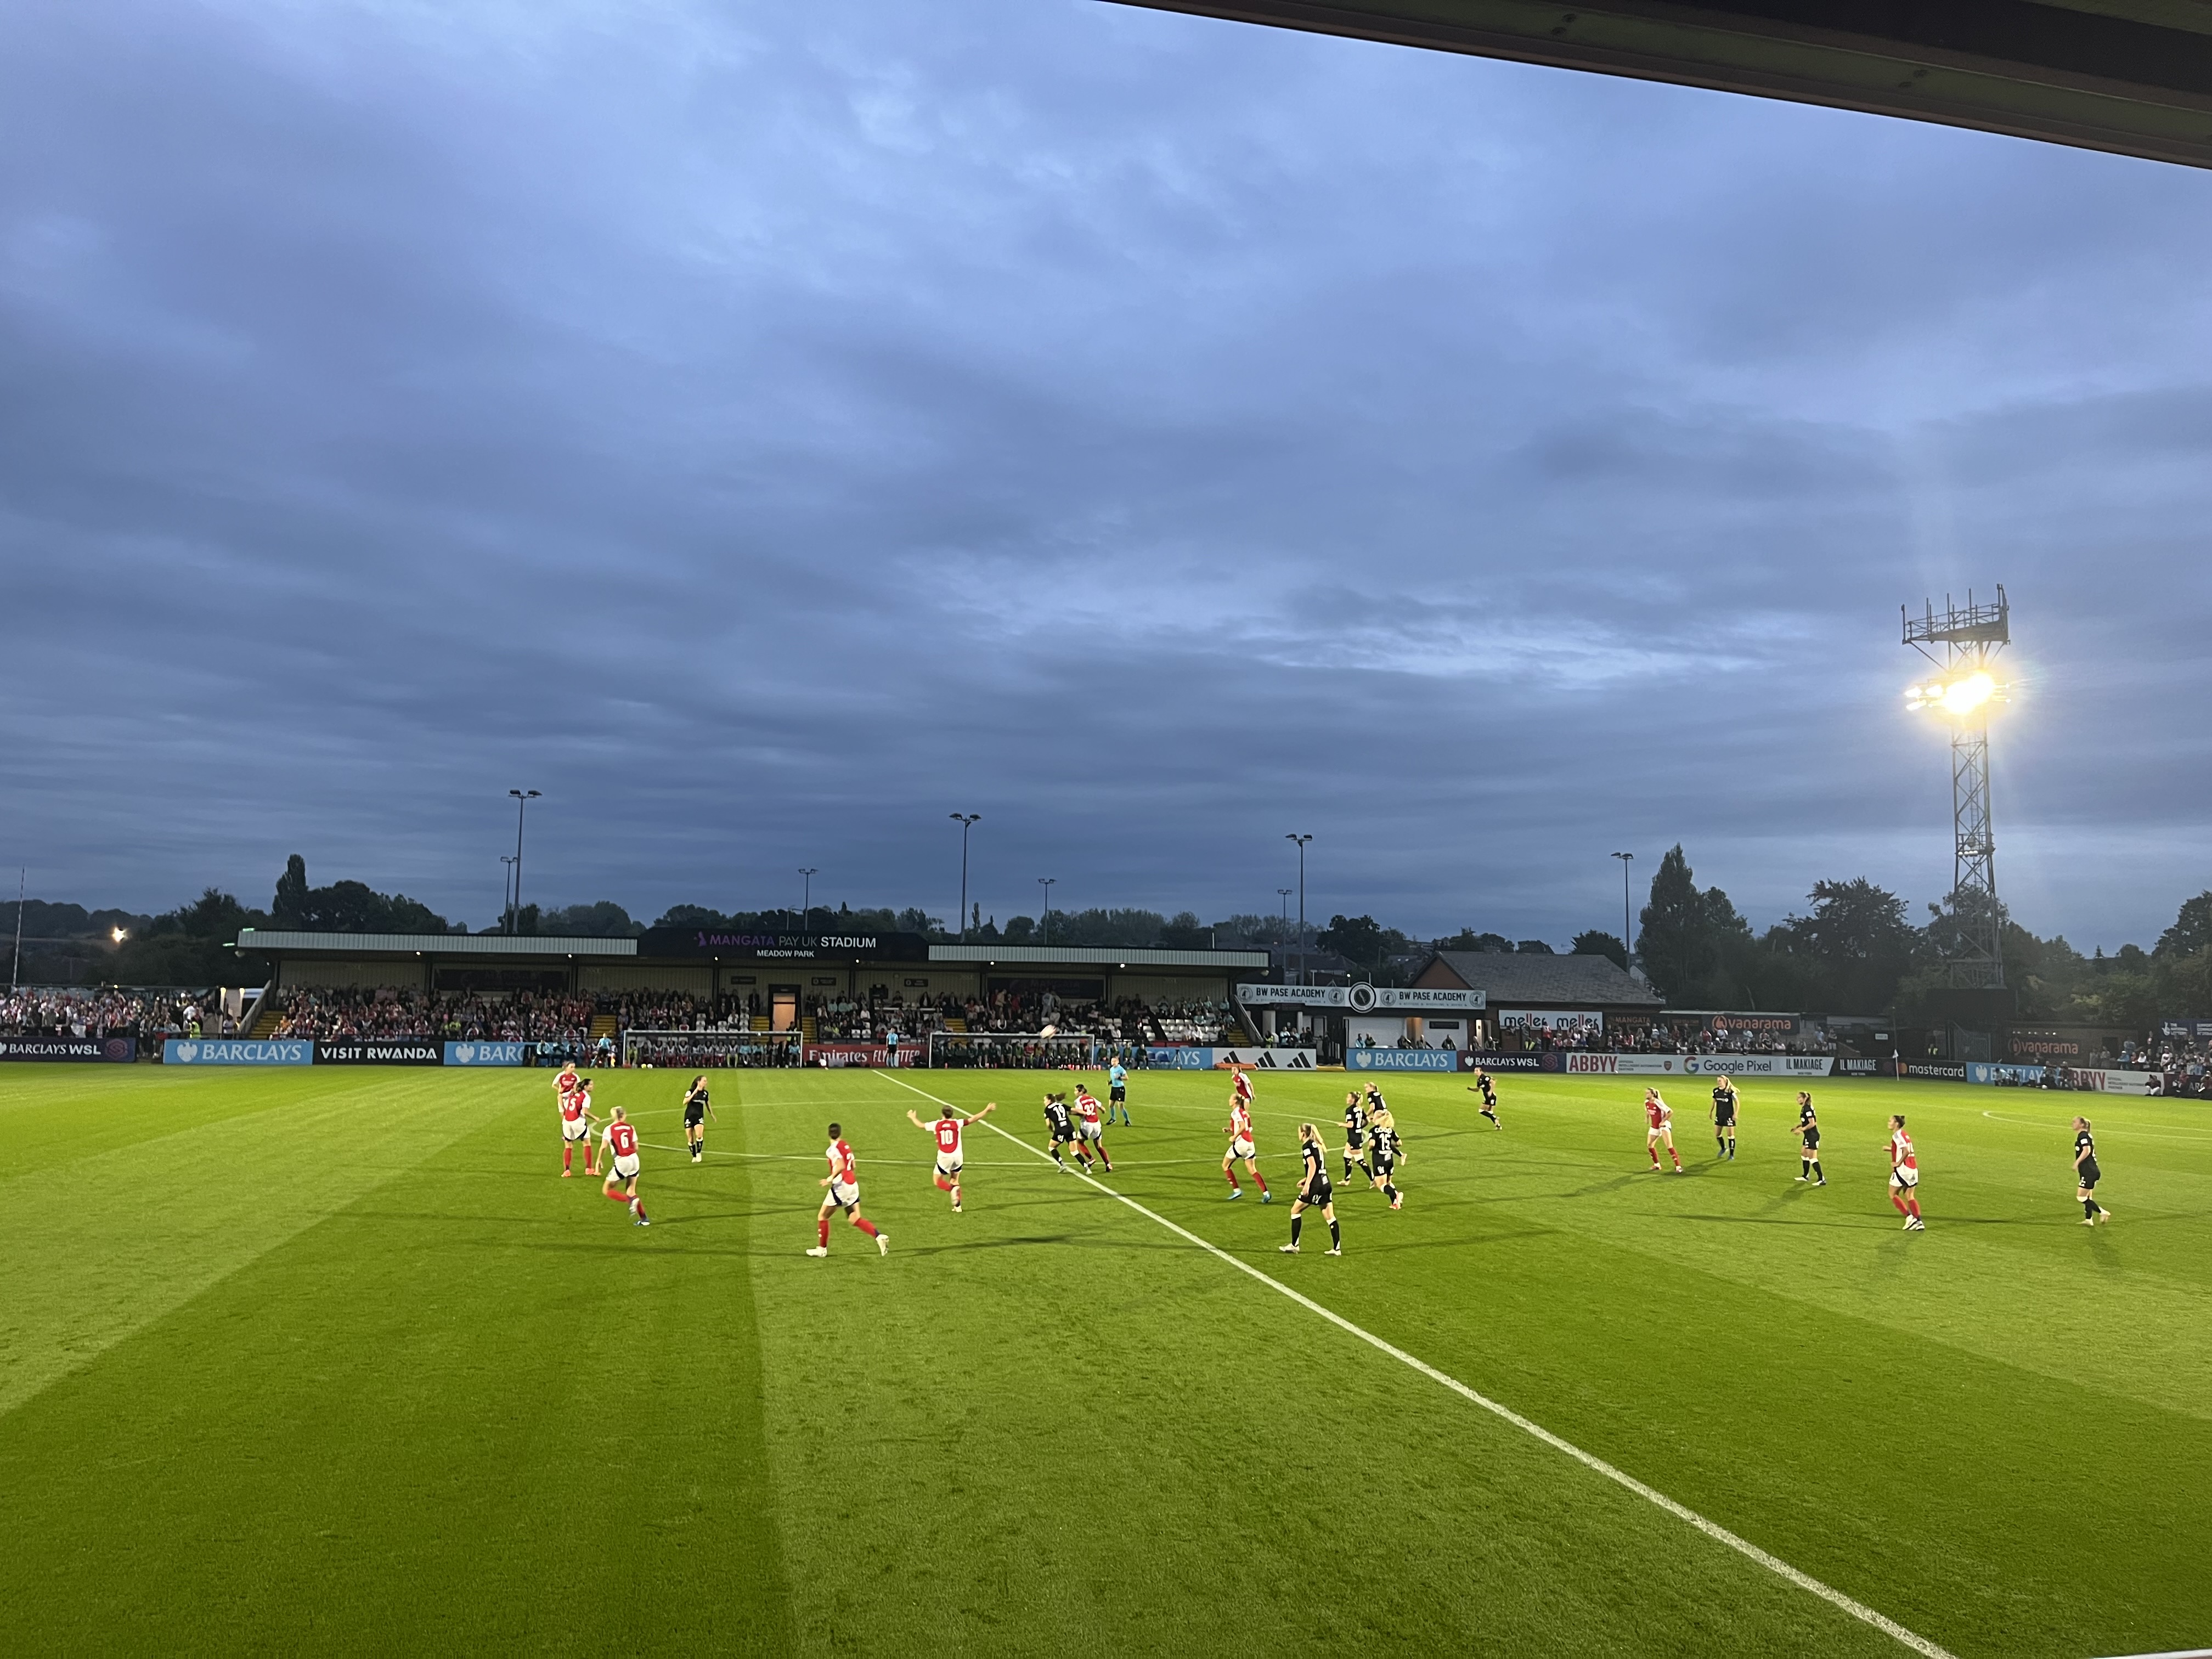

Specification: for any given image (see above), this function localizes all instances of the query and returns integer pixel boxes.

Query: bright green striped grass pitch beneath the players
[0,1066,2212,1655]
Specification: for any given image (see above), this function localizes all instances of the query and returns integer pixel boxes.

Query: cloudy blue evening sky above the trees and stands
[0,0,2212,949]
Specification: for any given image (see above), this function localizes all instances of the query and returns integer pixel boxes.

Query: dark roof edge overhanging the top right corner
[1124,0,2212,166]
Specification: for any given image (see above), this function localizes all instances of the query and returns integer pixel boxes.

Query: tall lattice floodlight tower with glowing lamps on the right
[1898,582,2013,991]
